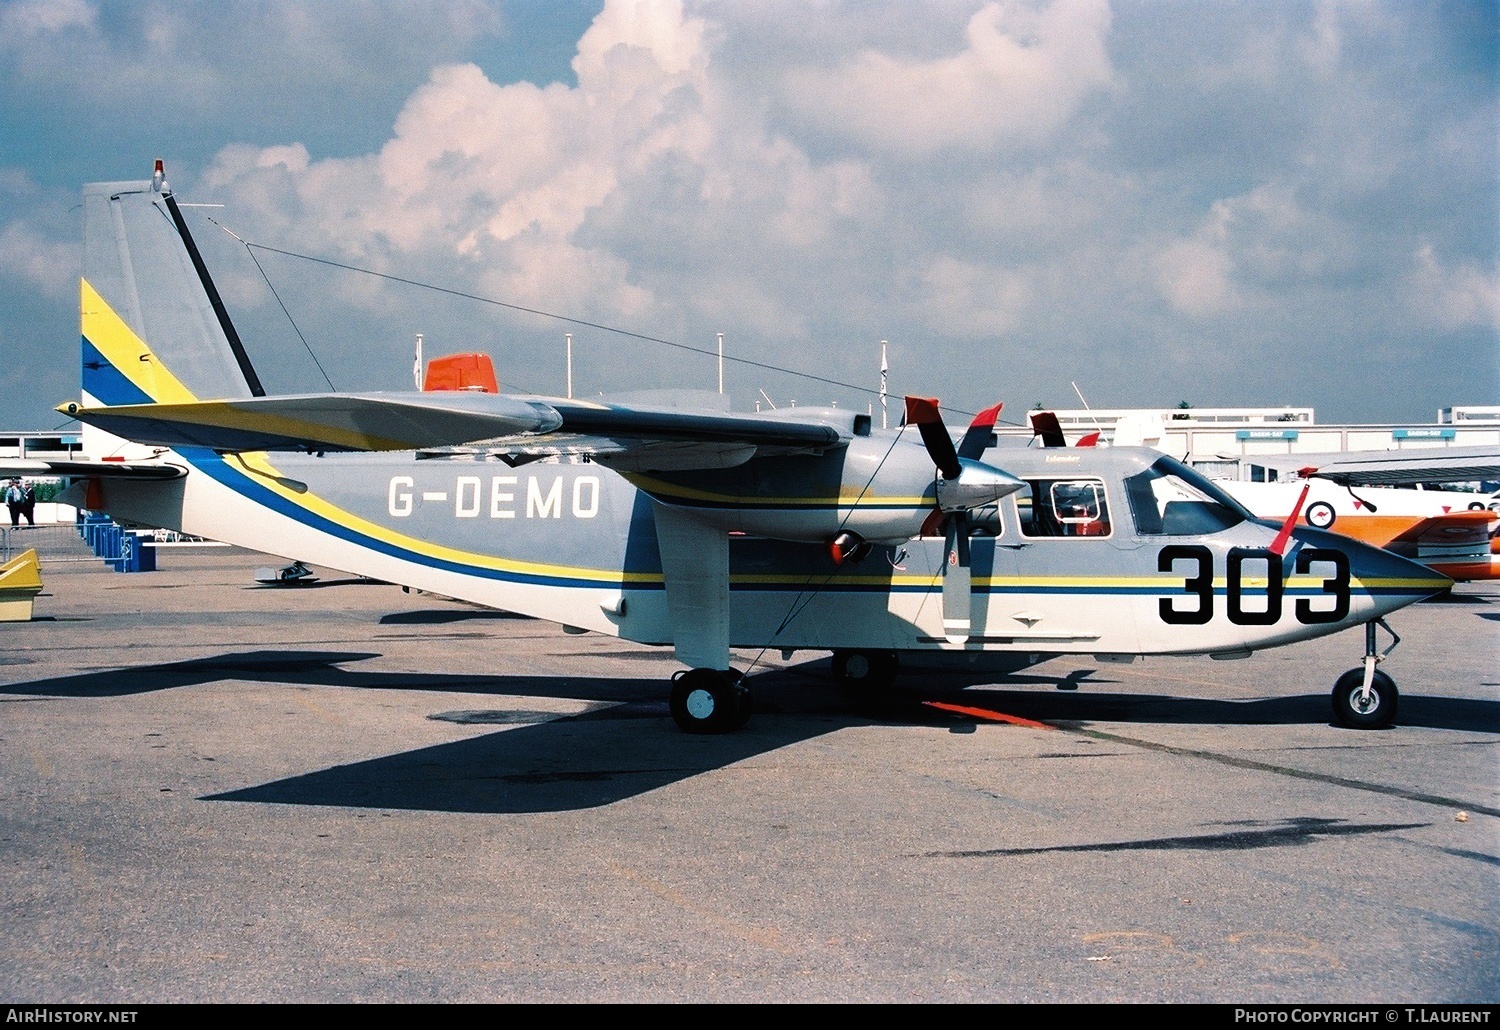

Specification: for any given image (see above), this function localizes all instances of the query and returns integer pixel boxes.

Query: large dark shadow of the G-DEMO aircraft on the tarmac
[0,651,1500,813]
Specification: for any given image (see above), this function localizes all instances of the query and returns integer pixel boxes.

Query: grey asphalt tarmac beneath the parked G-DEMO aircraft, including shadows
[0,534,1500,1005]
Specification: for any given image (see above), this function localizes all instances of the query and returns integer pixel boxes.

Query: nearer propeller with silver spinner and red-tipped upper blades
[906,397,1026,643]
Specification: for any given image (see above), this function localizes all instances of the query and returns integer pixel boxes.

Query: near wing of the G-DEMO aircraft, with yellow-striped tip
[59,391,849,468]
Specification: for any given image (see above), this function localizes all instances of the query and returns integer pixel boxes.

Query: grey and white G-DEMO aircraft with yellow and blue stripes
[59,163,1451,733]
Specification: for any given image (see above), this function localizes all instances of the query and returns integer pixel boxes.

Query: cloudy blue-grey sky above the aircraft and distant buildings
[0,0,1500,430]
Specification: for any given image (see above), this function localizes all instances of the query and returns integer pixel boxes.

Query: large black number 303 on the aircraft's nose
[1157,544,1349,625]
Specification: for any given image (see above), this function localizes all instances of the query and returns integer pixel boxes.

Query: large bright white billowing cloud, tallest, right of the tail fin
[203,0,872,338]
